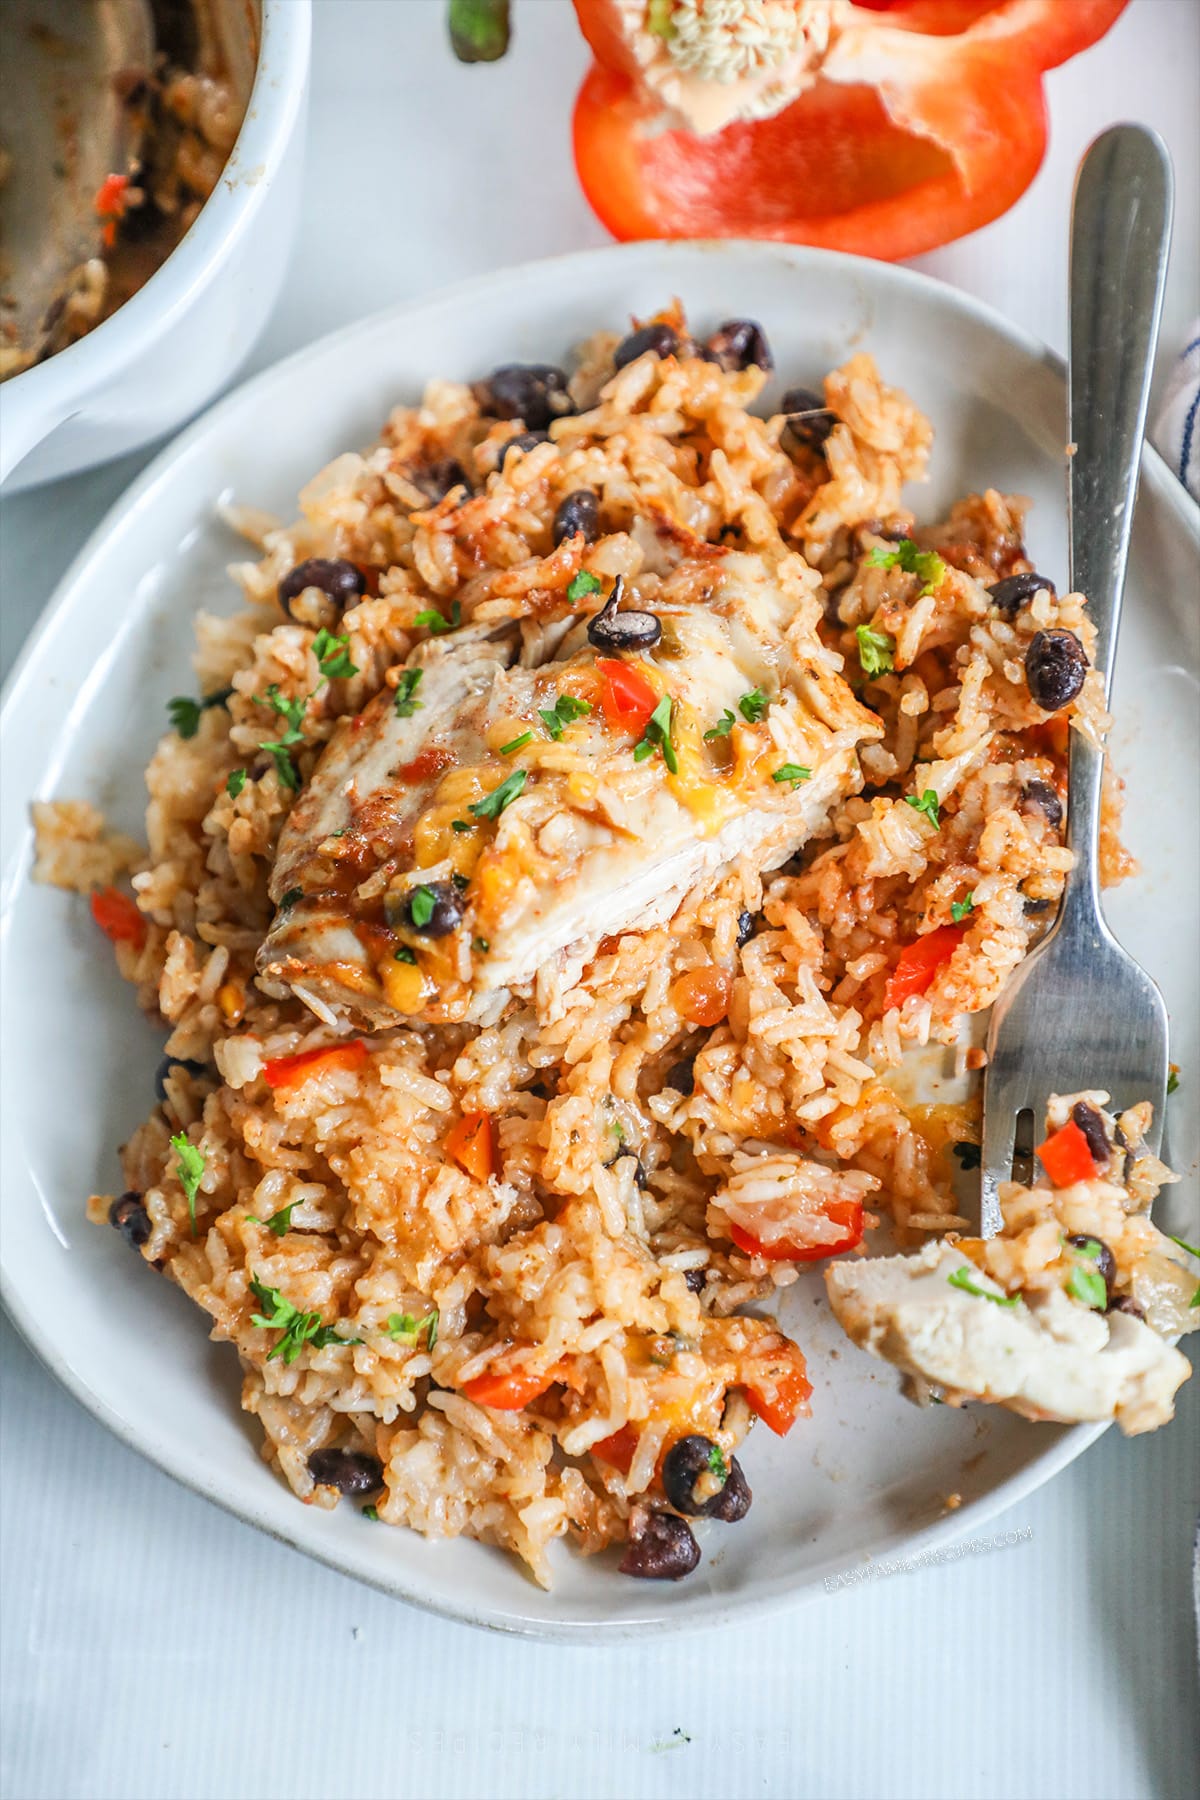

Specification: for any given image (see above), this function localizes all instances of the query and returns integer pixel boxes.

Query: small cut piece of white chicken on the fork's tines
[826,1244,1191,1435]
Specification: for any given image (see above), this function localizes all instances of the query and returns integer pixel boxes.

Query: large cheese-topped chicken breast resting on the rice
[259,553,880,1026]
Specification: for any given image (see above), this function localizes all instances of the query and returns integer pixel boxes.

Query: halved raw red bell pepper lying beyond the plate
[574,0,1126,259]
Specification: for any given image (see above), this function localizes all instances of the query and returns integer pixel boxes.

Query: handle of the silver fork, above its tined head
[1063,124,1173,916]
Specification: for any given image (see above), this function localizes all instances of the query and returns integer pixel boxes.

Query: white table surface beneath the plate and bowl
[0,0,1200,1800]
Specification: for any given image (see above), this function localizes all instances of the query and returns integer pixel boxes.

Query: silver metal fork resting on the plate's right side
[981,124,1173,1237]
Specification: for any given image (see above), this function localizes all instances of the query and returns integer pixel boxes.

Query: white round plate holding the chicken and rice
[0,243,1200,1638]
